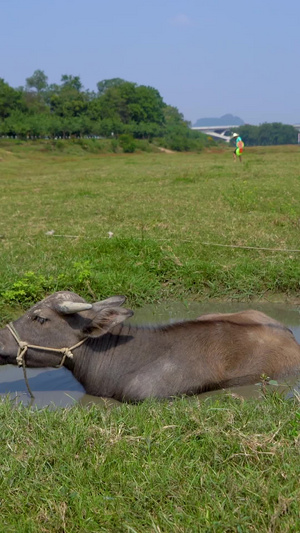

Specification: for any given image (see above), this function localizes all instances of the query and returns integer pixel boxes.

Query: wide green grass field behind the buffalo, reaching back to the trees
[0,141,300,318]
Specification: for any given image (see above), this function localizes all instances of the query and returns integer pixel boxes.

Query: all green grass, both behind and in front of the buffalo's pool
[0,140,300,533]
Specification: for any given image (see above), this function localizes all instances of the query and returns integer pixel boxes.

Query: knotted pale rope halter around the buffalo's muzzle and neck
[6,322,87,398]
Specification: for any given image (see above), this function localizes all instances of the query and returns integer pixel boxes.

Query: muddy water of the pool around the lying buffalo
[0,302,300,408]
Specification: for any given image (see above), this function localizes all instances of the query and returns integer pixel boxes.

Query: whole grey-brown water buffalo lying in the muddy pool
[0,291,300,401]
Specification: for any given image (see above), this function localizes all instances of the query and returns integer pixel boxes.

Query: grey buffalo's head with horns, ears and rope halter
[0,291,133,367]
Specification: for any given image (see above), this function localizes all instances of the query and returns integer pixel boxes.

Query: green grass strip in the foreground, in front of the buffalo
[0,395,300,533]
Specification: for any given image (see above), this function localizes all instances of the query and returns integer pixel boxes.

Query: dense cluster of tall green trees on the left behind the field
[0,70,214,150]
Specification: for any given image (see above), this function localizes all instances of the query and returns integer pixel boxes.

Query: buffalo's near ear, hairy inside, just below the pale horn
[83,307,133,338]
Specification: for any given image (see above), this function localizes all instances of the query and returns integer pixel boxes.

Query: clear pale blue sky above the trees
[0,0,300,124]
